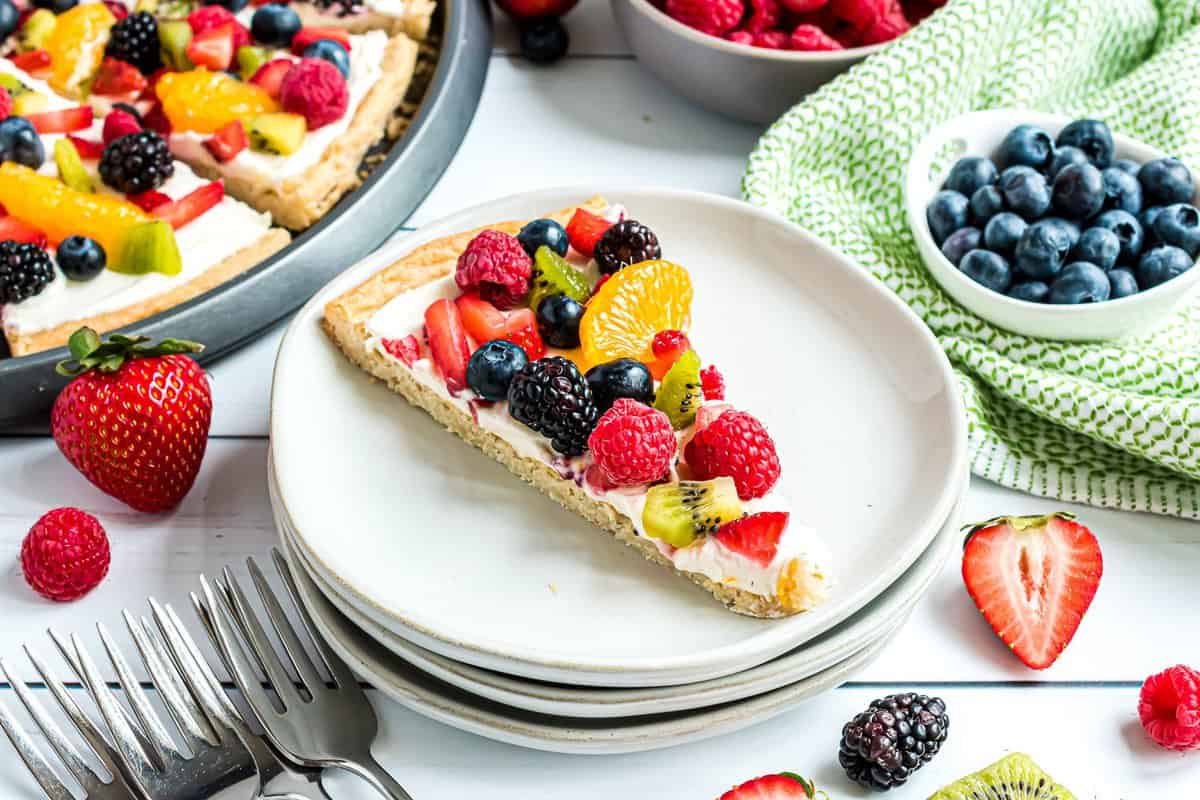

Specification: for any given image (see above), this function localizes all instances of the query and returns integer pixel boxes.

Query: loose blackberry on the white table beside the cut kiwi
[838,692,950,792]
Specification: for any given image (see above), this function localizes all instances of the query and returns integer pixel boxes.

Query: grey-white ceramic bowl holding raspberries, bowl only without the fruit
[612,0,887,124]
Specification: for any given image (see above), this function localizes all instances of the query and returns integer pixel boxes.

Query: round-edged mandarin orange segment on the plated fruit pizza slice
[580,260,692,367]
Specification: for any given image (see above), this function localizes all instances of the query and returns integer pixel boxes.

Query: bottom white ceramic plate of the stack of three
[284,532,902,754]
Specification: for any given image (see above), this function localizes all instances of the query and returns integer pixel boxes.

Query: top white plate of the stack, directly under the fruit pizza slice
[271,187,966,686]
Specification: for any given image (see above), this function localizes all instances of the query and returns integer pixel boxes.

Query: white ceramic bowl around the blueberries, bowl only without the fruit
[905,109,1200,342]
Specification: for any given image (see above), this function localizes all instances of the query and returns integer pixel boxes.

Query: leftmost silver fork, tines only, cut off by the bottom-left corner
[0,646,137,800]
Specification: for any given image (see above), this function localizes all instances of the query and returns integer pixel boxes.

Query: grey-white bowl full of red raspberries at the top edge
[611,0,946,122]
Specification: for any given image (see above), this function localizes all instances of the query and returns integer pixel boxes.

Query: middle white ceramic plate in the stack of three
[269,455,967,718]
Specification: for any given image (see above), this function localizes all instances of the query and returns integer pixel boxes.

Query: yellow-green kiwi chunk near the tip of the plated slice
[642,477,742,547]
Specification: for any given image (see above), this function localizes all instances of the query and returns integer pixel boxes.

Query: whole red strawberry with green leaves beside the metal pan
[50,327,212,511]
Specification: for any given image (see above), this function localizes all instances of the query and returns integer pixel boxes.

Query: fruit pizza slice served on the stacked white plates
[324,198,832,618]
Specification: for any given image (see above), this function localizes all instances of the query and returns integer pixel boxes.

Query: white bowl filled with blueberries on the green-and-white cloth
[905,109,1200,341]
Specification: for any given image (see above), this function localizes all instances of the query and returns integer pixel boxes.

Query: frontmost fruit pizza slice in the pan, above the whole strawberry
[0,60,289,356]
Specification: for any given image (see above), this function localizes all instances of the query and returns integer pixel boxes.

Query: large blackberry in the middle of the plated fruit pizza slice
[509,355,600,456]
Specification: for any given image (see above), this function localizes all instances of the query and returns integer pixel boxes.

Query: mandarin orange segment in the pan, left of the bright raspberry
[155,68,280,133]
